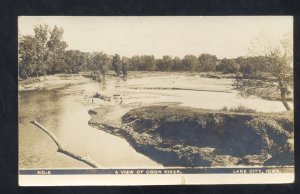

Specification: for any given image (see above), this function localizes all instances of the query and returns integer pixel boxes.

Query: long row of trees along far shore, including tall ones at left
[19,24,276,78]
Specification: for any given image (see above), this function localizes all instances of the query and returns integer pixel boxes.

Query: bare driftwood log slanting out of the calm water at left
[30,119,99,168]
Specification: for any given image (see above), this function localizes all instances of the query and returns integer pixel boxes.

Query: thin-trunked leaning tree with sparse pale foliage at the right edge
[234,34,293,110]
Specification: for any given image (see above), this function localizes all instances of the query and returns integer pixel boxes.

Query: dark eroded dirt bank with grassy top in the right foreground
[89,105,293,166]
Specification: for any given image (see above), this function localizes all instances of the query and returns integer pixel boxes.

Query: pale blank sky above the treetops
[18,16,293,58]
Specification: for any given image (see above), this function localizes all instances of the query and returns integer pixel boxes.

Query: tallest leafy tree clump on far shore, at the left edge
[19,24,67,78]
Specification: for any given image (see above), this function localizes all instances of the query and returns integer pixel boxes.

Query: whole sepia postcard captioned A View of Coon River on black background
[18,16,294,186]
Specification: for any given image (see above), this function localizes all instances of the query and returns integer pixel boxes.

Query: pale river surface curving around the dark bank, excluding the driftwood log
[19,75,290,169]
